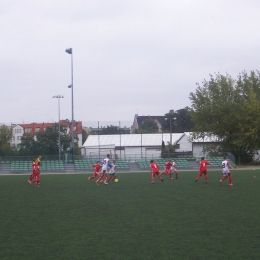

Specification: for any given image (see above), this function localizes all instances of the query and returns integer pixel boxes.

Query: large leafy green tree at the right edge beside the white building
[190,71,260,161]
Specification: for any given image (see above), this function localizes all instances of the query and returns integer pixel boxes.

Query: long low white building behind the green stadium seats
[81,132,220,159]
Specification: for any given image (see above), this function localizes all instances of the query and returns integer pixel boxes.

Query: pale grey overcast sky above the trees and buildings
[0,0,260,125]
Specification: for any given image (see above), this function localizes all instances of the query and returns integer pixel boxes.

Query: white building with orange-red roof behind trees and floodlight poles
[10,120,82,147]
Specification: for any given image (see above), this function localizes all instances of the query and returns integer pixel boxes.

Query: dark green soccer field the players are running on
[0,170,260,260]
